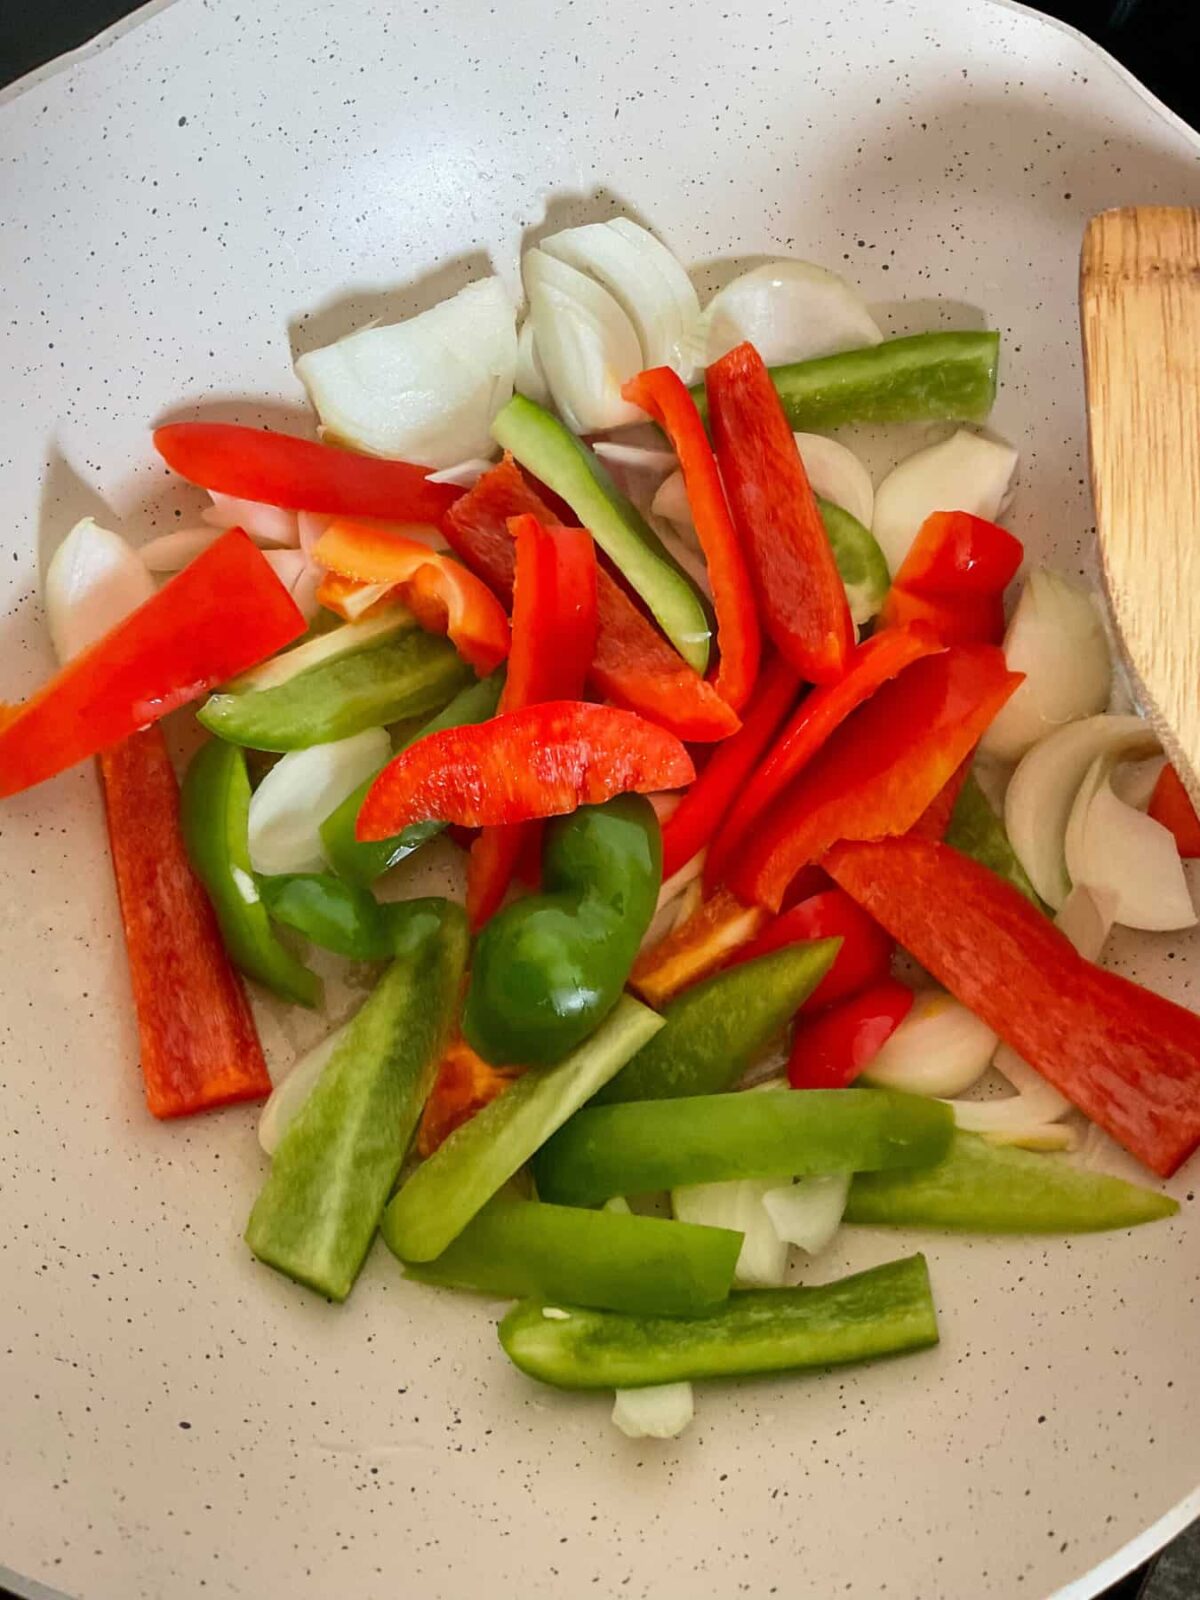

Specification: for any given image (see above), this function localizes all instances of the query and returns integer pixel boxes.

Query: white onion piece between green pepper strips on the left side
[250,728,392,874]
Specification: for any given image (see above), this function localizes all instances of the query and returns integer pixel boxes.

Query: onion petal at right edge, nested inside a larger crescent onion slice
[1064,754,1197,933]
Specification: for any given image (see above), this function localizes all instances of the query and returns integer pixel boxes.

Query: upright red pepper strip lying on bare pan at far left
[99,728,270,1117]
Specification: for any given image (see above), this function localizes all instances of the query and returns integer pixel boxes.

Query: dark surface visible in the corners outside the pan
[0,0,1200,1600]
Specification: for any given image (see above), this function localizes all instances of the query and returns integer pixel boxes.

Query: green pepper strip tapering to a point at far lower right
[845,1133,1179,1234]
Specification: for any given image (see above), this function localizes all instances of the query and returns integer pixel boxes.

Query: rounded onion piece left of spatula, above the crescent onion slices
[979,568,1112,762]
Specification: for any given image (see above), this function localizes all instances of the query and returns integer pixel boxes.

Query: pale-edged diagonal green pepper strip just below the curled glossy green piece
[387,995,662,1261]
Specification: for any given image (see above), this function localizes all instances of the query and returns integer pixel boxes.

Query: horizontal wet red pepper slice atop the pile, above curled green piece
[357,701,696,840]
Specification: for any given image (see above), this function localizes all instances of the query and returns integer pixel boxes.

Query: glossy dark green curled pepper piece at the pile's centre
[462,795,662,1066]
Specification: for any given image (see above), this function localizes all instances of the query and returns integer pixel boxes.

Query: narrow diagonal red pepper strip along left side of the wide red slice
[704,627,944,888]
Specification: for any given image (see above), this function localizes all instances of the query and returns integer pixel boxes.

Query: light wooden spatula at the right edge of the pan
[1080,206,1200,803]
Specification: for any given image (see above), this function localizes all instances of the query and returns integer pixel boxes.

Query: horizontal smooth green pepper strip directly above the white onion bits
[533,1090,954,1205]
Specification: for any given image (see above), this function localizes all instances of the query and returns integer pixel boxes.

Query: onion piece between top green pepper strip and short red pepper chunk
[870,427,1018,573]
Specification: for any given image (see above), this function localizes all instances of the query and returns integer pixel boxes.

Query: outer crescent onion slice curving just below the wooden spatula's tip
[1005,717,1158,910]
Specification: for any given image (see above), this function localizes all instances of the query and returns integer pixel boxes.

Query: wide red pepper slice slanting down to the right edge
[826,838,1200,1178]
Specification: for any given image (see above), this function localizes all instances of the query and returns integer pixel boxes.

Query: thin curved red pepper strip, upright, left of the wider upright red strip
[621,366,762,710]
